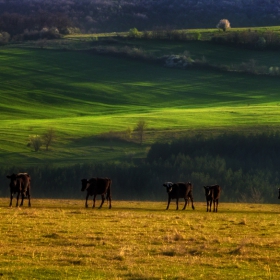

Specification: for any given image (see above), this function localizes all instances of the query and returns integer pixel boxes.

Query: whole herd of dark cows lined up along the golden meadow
[7,173,280,212]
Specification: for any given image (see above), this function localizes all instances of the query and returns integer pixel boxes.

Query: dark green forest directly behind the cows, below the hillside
[0,132,280,203]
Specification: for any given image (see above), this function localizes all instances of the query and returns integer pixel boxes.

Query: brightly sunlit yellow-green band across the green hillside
[1,104,280,137]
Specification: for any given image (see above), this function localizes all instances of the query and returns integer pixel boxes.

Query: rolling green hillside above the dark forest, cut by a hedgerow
[0,34,280,164]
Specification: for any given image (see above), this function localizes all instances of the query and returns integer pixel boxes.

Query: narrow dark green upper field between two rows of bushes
[64,32,280,67]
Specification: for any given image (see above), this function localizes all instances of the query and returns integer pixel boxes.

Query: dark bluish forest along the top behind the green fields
[0,0,280,36]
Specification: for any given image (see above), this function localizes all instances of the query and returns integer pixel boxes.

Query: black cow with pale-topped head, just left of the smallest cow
[163,182,195,210]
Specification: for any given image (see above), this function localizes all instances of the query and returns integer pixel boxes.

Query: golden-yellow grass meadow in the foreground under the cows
[0,198,280,280]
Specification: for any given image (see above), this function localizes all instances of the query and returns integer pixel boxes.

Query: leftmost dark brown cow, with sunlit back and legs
[7,173,31,207]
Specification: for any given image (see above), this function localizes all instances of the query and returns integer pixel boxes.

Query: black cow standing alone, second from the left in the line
[81,178,112,209]
